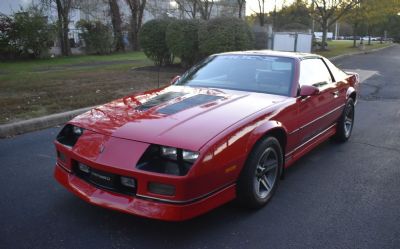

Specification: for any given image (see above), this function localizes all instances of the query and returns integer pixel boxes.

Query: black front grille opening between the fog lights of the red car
[72,161,137,195]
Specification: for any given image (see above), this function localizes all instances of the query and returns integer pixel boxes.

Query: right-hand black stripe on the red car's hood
[158,94,223,115]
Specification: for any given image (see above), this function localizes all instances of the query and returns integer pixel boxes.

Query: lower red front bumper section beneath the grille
[54,164,236,221]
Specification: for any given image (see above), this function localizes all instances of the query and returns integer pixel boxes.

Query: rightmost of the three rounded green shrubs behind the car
[199,17,254,56]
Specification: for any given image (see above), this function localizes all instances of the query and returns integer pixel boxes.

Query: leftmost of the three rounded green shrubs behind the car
[139,19,173,66]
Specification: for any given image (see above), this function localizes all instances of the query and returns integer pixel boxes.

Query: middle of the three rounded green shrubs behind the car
[166,19,200,67]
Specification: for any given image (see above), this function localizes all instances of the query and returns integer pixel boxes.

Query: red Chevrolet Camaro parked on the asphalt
[55,51,359,221]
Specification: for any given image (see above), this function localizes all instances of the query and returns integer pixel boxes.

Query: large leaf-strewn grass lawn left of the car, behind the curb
[0,52,181,124]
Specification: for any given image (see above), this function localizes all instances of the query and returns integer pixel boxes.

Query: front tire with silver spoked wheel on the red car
[237,137,283,208]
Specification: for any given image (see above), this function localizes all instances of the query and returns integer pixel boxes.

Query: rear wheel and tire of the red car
[334,98,354,143]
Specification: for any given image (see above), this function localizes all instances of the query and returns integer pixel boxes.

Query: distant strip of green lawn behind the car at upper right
[315,40,391,58]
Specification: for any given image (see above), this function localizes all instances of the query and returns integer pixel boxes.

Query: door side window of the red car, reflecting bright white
[299,58,332,87]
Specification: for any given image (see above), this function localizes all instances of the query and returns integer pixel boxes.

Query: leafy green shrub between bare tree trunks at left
[76,20,113,54]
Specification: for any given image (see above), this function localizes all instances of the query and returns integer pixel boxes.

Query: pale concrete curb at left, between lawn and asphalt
[0,107,93,138]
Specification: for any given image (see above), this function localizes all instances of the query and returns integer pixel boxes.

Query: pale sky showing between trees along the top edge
[0,0,293,15]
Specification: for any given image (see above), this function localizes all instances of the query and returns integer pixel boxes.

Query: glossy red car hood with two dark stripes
[70,86,287,151]
